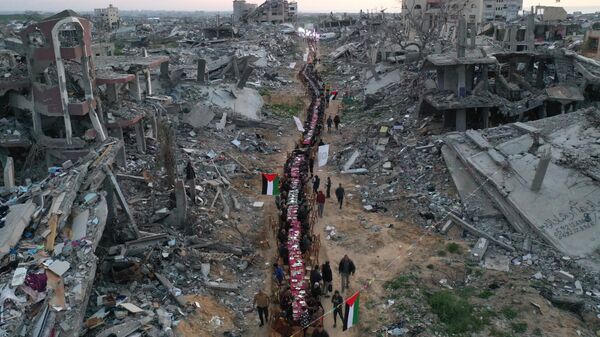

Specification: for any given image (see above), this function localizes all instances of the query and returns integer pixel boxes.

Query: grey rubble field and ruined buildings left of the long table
[0,10,302,336]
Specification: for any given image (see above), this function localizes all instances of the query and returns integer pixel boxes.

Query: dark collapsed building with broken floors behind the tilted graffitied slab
[420,16,600,131]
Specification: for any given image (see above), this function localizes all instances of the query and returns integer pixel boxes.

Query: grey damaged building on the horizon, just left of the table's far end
[233,0,298,23]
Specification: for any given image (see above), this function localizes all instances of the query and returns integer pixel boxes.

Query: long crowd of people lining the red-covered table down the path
[254,37,356,337]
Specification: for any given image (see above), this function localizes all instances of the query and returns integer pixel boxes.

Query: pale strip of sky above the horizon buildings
[0,0,600,12]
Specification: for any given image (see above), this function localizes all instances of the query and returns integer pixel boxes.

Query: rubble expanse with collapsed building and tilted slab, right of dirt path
[314,9,600,335]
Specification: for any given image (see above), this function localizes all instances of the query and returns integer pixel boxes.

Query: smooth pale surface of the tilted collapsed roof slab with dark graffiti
[445,113,600,256]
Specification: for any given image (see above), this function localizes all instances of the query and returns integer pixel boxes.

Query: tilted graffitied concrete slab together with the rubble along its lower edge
[442,109,600,312]
